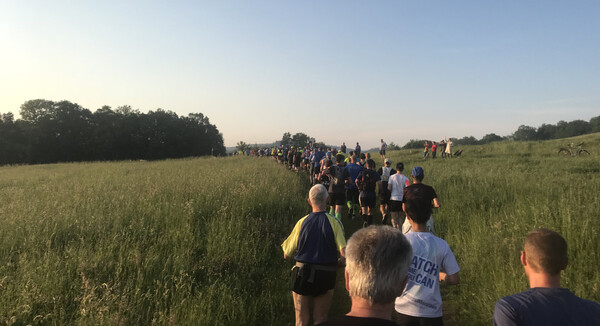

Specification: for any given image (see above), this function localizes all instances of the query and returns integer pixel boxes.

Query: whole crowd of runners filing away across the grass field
[276,139,600,326]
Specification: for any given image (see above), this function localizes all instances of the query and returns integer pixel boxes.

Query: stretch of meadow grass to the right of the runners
[382,134,600,325]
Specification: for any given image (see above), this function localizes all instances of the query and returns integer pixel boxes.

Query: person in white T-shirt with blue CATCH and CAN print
[395,187,460,326]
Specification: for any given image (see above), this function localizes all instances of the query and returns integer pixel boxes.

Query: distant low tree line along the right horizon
[402,116,600,149]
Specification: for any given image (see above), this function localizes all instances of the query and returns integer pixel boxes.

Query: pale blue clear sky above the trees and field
[0,0,600,148]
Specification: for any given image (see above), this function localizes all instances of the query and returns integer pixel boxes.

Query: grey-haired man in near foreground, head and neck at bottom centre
[320,226,413,326]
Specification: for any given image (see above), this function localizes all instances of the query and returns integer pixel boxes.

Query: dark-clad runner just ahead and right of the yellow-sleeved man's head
[324,153,350,221]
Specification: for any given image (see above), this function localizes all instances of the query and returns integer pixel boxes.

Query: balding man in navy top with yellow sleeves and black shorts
[281,185,346,326]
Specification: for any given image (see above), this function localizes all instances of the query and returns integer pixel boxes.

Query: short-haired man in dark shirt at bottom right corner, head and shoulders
[494,229,600,326]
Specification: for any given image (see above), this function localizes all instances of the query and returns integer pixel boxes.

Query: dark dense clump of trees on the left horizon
[0,99,225,164]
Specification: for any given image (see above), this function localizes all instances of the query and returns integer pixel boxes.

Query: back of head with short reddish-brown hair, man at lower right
[524,228,568,275]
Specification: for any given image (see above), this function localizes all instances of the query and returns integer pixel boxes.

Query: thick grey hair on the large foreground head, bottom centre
[346,226,413,304]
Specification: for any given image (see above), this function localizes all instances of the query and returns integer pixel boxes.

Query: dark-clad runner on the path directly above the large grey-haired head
[356,159,381,227]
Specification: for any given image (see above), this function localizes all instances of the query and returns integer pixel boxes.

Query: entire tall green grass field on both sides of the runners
[0,134,600,325]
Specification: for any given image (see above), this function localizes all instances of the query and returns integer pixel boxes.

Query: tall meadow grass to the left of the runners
[0,158,308,325]
